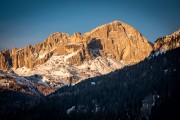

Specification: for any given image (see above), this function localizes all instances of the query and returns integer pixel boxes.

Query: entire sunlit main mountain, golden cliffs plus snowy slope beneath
[0,21,153,90]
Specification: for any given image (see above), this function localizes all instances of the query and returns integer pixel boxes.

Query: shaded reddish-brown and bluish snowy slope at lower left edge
[0,70,55,96]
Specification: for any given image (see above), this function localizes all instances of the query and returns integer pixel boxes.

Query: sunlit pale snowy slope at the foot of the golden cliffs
[13,51,125,88]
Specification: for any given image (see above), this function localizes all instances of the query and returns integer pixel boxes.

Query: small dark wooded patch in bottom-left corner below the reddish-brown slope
[0,89,40,119]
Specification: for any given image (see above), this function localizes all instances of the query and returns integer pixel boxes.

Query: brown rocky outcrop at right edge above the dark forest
[154,30,180,51]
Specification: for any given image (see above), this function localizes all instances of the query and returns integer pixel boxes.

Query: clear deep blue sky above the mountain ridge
[0,0,180,50]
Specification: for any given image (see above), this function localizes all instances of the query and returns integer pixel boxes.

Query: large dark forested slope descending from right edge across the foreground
[2,48,180,120]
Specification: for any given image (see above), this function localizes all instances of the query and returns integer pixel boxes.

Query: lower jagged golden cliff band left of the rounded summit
[11,32,69,69]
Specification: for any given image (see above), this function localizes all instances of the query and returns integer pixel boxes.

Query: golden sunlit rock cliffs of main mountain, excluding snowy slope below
[0,21,152,69]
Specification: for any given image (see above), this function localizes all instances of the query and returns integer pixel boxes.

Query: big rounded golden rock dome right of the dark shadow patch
[85,21,152,63]
